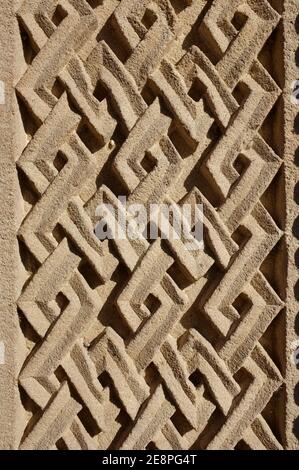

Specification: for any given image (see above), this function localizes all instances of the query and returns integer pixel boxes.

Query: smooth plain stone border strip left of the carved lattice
[0,0,18,449]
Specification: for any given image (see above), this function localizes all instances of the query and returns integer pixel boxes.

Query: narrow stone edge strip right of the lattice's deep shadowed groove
[283,0,299,450]
